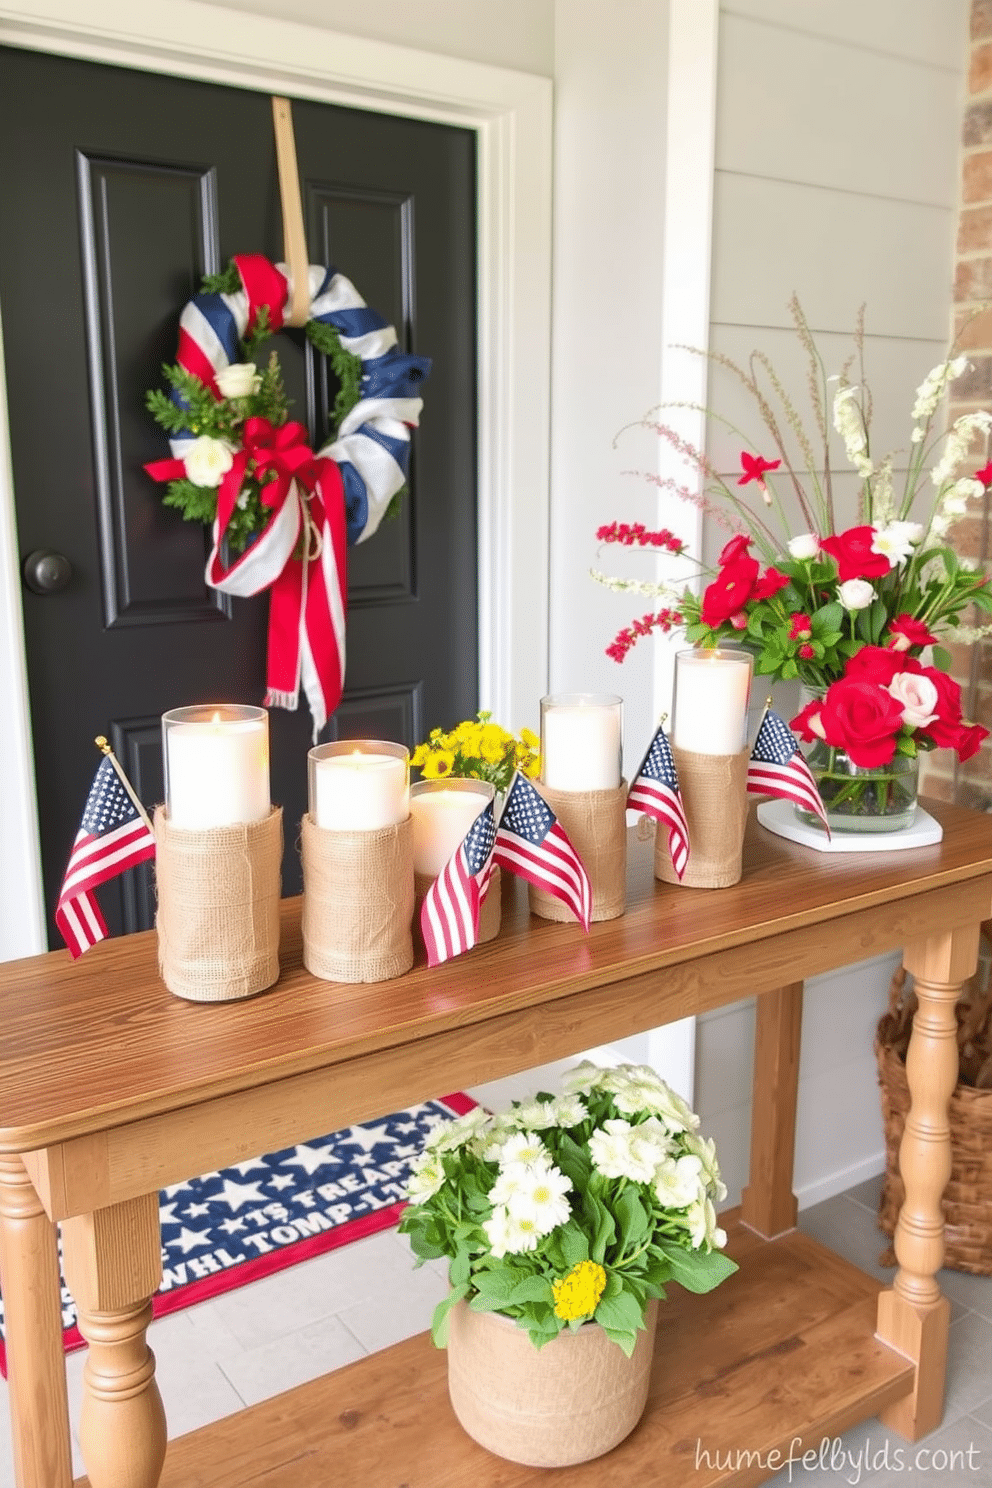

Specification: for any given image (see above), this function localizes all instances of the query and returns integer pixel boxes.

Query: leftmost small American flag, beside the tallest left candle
[55,754,155,958]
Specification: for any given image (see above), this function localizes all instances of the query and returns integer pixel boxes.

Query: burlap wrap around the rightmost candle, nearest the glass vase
[654,744,750,888]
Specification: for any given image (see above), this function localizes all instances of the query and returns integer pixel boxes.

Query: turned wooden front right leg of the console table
[877,926,979,1442]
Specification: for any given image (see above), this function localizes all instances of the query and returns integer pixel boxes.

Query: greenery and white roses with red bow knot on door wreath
[146,262,361,552]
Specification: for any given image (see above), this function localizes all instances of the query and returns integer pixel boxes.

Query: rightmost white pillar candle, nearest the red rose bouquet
[672,650,754,754]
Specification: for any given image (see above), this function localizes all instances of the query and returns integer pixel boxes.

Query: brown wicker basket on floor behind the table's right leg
[875,921,992,1277]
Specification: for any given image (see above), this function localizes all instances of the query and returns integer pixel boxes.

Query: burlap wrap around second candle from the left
[300,815,413,982]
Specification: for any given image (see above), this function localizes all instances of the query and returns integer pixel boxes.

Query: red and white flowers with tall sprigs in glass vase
[592,298,992,768]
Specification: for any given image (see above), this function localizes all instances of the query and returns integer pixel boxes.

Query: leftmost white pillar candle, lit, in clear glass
[162,704,272,830]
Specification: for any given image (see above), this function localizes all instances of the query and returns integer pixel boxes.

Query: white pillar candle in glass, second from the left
[309,740,410,832]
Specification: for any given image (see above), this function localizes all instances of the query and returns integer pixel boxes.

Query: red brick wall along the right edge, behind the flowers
[924,0,992,811]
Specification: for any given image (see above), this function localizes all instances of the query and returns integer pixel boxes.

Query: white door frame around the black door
[0,0,552,960]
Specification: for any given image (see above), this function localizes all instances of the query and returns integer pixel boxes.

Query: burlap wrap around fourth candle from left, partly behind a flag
[528,780,628,924]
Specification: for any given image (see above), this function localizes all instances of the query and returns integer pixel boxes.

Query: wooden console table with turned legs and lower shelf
[0,804,992,1488]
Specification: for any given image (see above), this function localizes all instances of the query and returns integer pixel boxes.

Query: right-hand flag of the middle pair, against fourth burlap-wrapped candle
[494,771,592,930]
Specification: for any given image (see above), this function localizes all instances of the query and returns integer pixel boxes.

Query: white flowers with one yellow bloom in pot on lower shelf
[400,1062,738,1357]
